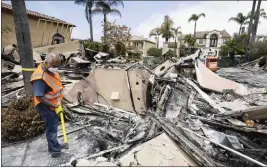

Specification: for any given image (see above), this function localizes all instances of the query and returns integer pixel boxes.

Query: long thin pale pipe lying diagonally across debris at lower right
[177,125,267,167]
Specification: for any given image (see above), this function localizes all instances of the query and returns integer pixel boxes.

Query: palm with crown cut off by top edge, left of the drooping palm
[74,0,95,41]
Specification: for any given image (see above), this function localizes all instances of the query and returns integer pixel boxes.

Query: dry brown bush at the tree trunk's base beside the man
[1,97,44,145]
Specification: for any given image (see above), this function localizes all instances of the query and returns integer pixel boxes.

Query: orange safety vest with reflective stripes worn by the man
[30,64,63,110]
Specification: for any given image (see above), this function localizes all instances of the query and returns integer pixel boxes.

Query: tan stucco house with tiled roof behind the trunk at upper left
[1,3,76,48]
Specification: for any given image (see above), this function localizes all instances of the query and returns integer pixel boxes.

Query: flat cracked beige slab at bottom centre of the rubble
[119,133,198,166]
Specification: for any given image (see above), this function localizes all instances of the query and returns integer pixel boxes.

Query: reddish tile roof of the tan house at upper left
[1,3,76,27]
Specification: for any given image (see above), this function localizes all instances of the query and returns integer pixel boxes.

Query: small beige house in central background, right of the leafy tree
[129,36,157,56]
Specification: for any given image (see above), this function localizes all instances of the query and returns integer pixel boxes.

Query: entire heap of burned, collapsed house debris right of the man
[2,43,267,166]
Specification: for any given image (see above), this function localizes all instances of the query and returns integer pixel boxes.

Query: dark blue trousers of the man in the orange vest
[36,104,61,153]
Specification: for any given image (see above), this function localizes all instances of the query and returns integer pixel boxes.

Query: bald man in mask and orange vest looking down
[30,53,63,157]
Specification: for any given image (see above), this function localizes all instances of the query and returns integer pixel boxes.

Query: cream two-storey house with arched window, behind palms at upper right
[168,30,231,56]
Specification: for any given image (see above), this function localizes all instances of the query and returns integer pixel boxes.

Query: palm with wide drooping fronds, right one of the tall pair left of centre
[92,0,124,45]
